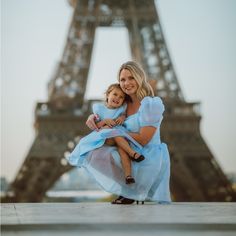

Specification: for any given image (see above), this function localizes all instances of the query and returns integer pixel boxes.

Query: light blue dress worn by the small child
[68,103,141,167]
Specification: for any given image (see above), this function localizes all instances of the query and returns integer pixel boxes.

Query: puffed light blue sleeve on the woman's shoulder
[139,97,165,128]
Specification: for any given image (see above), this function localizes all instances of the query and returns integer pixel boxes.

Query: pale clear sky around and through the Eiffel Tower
[1,0,236,183]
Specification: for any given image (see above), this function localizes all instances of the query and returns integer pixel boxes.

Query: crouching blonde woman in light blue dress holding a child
[83,61,171,204]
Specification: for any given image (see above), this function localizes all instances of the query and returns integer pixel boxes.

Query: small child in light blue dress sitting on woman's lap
[69,84,145,184]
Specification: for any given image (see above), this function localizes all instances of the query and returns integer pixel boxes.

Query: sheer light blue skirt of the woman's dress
[69,137,171,203]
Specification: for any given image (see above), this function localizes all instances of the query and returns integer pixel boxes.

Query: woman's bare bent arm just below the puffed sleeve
[128,126,157,146]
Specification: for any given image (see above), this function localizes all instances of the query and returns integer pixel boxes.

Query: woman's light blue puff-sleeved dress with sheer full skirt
[68,97,171,203]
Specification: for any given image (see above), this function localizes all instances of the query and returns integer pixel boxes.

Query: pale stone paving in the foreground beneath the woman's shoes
[1,203,236,236]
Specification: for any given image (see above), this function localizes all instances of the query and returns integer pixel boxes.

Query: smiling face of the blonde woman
[119,69,138,96]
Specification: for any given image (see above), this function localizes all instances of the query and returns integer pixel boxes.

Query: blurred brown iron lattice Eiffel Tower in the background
[5,0,236,202]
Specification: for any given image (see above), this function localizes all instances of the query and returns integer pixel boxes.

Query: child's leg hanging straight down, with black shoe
[117,147,135,184]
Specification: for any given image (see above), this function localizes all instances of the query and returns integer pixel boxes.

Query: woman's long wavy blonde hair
[118,61,154,100]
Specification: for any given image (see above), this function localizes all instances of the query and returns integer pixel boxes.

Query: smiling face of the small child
[107,88,125,108]
